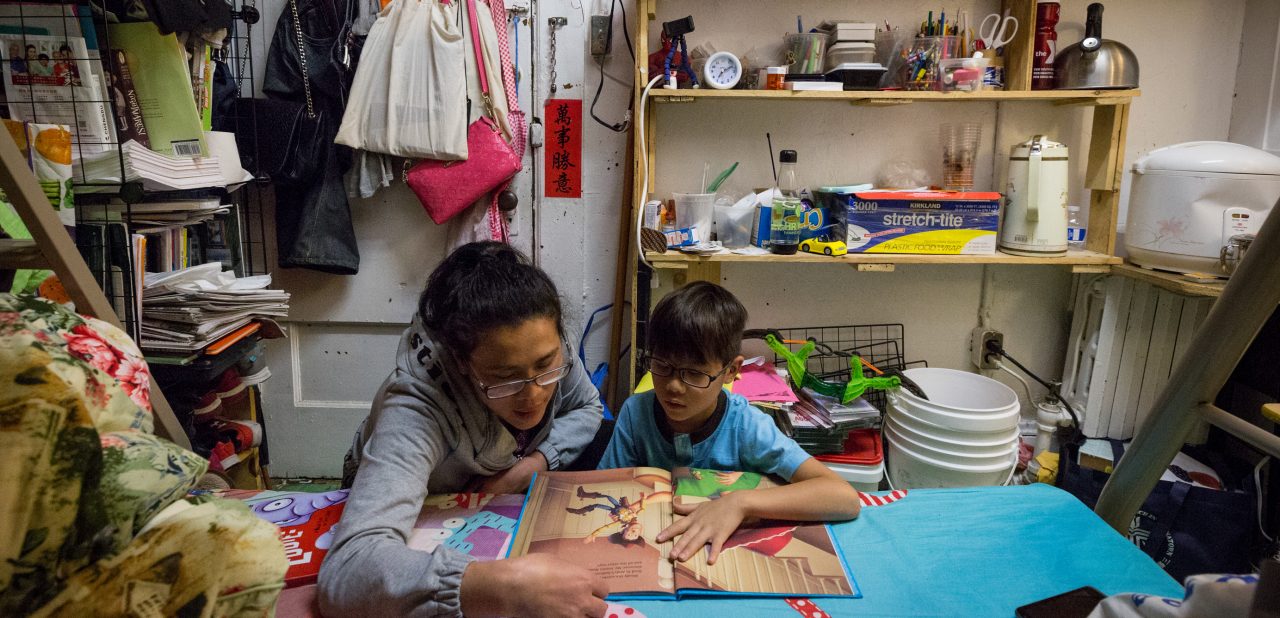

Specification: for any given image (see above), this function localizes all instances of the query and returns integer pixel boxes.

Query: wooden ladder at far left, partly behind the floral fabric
[0,132,191,449]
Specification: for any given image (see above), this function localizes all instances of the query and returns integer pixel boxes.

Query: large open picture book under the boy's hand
[508,468,861,600]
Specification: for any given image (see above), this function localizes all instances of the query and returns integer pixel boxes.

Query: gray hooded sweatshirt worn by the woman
[319,316,602,618]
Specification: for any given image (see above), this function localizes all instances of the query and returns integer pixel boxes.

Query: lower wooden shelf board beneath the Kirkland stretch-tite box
[645,251,1123,273]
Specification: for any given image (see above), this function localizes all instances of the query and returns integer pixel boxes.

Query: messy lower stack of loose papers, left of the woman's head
[141,262,289,352]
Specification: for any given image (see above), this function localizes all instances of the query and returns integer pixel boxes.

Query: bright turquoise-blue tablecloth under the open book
[625,485,1181,618]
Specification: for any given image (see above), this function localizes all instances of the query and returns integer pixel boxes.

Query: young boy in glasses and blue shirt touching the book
[600,281,859,564]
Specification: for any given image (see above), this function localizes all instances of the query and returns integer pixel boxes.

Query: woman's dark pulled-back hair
[419,242,564,361]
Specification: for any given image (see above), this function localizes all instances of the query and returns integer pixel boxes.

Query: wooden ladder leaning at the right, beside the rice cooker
[1094,203,1280,534]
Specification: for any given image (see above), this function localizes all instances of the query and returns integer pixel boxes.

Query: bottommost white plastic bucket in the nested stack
[884,431,1018,489]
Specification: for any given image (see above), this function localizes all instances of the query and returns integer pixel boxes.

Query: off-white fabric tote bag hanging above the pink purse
[335,0,467,160]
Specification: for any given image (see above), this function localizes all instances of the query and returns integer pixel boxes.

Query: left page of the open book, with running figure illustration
[517,468,676,594]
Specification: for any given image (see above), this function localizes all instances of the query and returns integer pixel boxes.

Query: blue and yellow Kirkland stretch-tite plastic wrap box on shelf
[822,191,1001,255]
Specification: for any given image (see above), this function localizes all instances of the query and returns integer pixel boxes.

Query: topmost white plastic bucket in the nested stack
[888,367,1019,434]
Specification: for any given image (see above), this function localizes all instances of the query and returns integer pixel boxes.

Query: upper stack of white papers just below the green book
[72,132,253,193]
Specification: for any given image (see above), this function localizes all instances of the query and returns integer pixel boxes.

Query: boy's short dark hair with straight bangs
[646,281,746,363]
